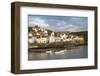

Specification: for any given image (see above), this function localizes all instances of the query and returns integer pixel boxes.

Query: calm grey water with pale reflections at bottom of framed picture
[28,46,88,60]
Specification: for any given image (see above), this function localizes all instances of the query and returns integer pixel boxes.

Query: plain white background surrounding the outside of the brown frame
[0,0,100,76]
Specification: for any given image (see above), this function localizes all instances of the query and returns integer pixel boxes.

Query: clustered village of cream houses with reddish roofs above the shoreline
[28,26,84,44]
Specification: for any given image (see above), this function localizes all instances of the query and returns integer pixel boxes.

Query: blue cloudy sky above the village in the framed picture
[28,15,88,32]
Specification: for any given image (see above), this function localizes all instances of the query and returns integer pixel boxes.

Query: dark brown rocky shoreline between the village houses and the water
[29,41,87,49]
